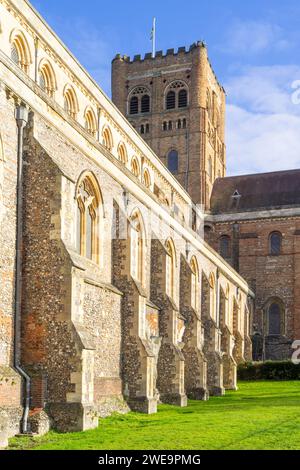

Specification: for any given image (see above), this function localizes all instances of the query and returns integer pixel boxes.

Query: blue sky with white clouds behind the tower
[32,0,300,174]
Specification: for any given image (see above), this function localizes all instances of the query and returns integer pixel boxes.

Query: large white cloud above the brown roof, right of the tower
[227,66,300,174]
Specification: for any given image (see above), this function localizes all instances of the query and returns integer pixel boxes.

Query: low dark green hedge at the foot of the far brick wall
[238,361,300,380]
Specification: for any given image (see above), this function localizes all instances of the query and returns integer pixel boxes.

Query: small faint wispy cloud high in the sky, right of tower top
[220,19,289,55]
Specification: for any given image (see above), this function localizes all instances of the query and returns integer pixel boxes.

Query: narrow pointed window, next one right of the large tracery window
[130,212,145,284]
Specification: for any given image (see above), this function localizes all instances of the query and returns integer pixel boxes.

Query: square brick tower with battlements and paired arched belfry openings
[112,42,226,209]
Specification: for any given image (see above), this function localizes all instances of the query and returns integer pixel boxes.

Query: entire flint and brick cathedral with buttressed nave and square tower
[0,0,300,446]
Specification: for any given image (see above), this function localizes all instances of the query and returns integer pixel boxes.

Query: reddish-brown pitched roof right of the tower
[211,169,300,214]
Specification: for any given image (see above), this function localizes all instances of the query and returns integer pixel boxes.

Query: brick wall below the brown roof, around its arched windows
[207,214,300,360]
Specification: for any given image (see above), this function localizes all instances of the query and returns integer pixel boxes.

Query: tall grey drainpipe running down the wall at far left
[14,105,30,434]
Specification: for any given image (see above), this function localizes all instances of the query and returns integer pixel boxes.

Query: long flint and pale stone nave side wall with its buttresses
[0,0,253,446]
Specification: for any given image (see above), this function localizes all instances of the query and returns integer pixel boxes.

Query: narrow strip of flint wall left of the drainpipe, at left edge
[0,89,22,444]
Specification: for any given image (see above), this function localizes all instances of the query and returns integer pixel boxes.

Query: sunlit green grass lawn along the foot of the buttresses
[10,382,300,450]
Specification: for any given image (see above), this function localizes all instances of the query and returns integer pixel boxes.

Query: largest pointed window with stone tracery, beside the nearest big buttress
[76,174,102,263]
